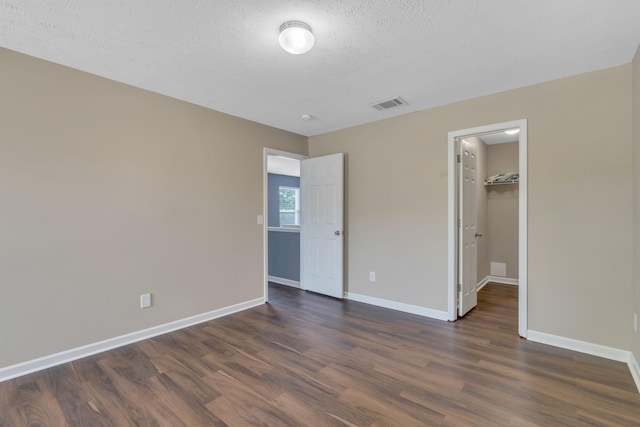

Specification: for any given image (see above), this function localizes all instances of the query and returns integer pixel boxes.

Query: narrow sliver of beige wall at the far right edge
[631,47,640,363]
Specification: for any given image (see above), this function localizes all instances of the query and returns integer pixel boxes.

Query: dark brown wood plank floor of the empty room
[0,284,640,427]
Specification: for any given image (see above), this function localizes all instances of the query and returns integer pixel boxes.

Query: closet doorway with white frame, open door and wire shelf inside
[448,120,527,338]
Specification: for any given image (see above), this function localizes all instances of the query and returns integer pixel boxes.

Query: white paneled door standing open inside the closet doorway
[458,139,480,316]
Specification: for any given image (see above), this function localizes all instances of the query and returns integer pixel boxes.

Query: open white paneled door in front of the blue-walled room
[300,153,344,298]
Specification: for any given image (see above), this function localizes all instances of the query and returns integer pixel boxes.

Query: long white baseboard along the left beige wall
[0,298,264,382]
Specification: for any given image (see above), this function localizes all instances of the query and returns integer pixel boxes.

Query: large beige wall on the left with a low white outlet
[0,49,307,367]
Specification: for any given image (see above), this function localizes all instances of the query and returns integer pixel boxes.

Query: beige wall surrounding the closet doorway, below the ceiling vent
[309,64,632,349]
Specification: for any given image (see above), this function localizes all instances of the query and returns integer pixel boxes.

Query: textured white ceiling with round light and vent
[0,0,640,136]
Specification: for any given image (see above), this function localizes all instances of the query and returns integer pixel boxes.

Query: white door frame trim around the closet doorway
[447,119,528,338]
